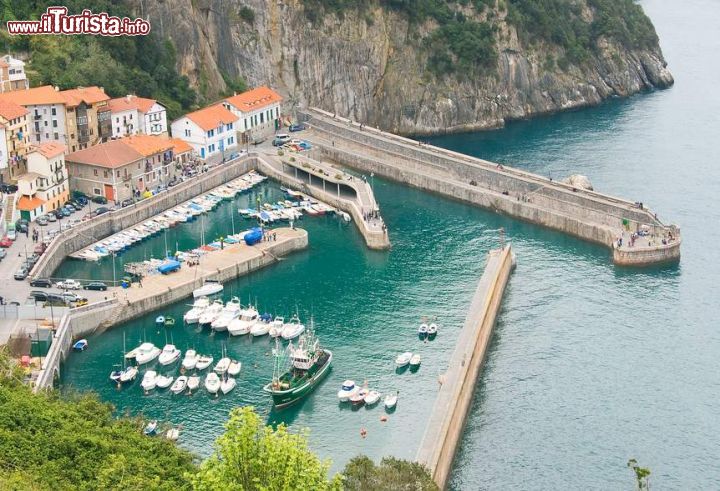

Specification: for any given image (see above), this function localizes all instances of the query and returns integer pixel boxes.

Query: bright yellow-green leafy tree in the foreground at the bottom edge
[192,407,342,491]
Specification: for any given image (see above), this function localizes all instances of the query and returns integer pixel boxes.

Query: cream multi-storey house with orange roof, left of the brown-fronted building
[0,85,67,145]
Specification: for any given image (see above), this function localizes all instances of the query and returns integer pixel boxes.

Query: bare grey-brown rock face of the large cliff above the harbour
[131,0,673,134]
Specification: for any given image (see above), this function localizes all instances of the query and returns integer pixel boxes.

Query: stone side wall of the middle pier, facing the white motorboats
[34,229,308,391]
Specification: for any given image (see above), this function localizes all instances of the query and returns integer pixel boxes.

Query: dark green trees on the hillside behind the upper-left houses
[0,0,197,119]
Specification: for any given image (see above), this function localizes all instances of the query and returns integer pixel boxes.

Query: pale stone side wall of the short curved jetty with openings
[257,158,390,249]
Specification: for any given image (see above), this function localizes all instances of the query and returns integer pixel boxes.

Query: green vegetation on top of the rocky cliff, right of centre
[304,0,657,78]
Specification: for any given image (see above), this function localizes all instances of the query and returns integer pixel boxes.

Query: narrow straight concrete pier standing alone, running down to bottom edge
[416,246,513,489]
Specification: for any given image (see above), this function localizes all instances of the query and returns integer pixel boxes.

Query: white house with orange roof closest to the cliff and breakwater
[223,86,282,143]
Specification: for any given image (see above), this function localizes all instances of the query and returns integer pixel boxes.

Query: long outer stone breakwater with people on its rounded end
[306,108,681,266]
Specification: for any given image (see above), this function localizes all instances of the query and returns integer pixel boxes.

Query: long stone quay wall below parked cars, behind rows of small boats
[30,155,256,278]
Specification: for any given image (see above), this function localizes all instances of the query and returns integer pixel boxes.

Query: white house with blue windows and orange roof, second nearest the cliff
[170,104,240,160]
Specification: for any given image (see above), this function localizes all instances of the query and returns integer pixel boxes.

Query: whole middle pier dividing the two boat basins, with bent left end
[34,228,308,391]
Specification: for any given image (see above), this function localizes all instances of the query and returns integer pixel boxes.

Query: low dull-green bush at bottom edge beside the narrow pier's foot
[343,455,438,491]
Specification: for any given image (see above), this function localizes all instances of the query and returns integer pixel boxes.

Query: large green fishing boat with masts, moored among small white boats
[263,321,332,409]
